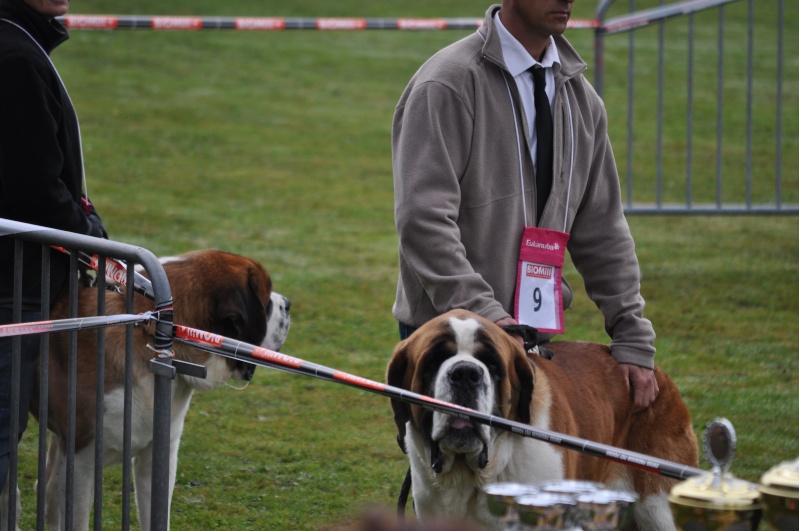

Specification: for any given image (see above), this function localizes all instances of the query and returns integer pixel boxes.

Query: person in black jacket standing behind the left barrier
[0,0,107,502]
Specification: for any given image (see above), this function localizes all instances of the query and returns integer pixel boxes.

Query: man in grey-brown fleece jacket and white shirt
[392,0,658,408]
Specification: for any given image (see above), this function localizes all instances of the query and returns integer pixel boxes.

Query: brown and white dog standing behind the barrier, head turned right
[38,250,290,530]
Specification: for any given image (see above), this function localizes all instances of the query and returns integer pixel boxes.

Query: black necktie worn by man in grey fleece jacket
[532,66,552,221]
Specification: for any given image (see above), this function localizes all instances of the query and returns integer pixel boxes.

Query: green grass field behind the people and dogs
[14,0,799,530]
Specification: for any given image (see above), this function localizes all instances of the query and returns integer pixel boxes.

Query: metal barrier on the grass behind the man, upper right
[594,0,799,215]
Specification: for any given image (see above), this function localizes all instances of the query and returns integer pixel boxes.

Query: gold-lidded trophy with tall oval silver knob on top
[669,419,763,531]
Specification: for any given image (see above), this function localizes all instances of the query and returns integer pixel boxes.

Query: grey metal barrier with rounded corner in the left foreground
[0,219,175,530]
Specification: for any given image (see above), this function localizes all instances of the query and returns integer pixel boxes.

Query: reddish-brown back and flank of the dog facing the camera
[533,342,698,528]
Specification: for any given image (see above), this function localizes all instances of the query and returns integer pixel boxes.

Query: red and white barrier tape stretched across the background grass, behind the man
[56,15,602,31]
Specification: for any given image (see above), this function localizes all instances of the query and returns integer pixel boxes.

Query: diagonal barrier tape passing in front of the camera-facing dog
[174,325,704,480]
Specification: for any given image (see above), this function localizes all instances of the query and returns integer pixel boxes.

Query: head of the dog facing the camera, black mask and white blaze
[387,310,533,474]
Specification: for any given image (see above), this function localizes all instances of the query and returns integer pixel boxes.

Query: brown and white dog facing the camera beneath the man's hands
[387,310,698,531]
